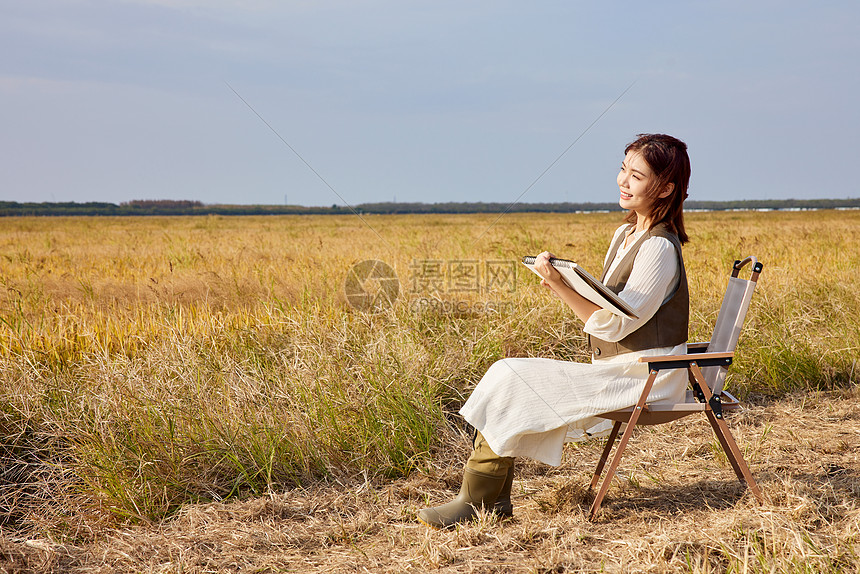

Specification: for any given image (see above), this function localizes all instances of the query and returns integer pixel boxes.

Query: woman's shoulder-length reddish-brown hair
[624,134,690,244]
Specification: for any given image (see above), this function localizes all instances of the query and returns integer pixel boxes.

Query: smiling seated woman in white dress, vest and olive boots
[418,134,690,528]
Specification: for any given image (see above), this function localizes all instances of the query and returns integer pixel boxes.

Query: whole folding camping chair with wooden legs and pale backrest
[589,257,764,520]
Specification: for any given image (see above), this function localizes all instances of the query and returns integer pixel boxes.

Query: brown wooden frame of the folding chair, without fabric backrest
[589,257,764,520]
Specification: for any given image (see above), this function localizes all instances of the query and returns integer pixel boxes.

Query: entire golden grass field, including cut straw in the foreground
[0,211,860,572]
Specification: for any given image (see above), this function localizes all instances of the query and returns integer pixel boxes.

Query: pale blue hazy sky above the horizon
[0,0,860,205]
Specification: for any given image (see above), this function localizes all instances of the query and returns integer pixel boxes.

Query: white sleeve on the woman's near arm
[583,237,680,342]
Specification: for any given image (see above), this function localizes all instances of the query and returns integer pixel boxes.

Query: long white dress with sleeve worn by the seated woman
[460,225,687,466]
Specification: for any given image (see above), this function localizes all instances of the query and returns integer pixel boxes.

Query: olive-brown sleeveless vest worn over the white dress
[588,225,690,359]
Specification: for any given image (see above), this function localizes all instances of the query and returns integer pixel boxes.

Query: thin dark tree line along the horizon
[0,198,860,216]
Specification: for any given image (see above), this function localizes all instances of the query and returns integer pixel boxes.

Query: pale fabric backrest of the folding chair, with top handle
[702,257,764,394]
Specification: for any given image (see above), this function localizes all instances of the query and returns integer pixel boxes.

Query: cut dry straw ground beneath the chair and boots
[0,389,860,573]
